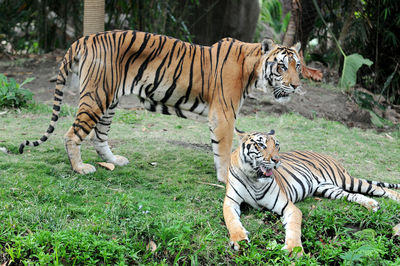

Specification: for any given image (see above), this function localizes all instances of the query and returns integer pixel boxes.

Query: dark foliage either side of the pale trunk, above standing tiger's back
[0,0,199,53]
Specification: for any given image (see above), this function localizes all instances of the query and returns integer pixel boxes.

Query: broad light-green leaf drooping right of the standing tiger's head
[340,53,372,89]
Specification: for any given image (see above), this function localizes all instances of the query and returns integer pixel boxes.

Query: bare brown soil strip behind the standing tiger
[0,51,374,129]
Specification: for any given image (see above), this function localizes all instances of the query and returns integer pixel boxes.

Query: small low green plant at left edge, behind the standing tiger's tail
[0,74,34,108]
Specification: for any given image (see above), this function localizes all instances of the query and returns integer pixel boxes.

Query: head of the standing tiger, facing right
[257,39,304,102]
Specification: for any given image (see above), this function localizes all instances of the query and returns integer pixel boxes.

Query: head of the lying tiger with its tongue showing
[235,129,280,178]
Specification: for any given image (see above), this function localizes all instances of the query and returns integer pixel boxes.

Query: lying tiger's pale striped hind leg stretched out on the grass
[314,183,379,211]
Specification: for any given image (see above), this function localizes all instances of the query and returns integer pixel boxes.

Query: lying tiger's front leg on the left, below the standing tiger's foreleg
[223,184,250,251]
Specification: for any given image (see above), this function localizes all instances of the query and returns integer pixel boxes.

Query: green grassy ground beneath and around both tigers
[0,105,400,265]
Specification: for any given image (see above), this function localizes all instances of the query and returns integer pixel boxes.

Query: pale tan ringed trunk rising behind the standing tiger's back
[83,0,105,35]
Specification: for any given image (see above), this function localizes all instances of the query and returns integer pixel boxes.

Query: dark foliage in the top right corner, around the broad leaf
[310,0,400,104]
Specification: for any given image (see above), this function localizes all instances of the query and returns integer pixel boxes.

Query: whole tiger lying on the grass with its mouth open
[223,131,400,254]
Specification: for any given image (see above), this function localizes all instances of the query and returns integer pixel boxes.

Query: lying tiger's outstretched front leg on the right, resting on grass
[282,202,303,256]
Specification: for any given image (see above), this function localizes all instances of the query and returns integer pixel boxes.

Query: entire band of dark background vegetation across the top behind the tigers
[0,0,400,105]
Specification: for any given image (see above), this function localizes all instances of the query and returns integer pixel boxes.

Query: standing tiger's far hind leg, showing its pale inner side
[90,102,129,166]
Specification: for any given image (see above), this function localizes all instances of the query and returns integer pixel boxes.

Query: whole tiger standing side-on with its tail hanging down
[19,30,301,182]
